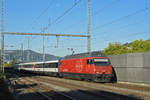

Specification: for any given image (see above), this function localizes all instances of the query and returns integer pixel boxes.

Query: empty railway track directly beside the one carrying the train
[27,78,145,100]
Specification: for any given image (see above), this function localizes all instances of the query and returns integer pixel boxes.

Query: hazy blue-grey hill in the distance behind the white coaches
[0,50,59,62]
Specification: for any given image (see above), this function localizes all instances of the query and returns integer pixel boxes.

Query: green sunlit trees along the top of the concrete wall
[102,40,150,55]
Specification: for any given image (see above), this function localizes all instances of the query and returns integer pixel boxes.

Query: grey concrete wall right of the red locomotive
[110,52,150,83]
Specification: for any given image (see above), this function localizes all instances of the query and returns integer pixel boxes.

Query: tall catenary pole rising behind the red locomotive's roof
[88,0,91,52]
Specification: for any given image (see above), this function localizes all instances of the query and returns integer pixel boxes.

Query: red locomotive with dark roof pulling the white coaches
[59,53,113,82]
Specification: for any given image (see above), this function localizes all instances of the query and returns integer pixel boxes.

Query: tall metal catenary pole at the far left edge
[1,0,5,73]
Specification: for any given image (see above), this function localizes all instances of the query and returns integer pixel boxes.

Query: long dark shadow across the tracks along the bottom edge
[15,85,143,100]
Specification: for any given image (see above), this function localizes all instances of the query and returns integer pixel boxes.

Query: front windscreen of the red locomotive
[94,59,110,66]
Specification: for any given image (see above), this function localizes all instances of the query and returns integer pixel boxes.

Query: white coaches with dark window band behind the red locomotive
[14,60,58,76]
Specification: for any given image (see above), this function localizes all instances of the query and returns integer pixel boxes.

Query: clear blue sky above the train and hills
[0,0,150,56]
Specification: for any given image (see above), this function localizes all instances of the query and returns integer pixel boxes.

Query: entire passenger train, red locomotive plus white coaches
[14,52,114,82]
